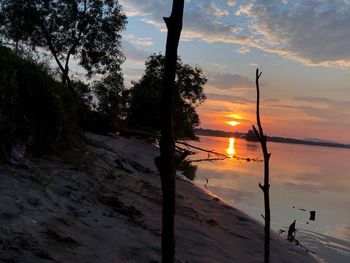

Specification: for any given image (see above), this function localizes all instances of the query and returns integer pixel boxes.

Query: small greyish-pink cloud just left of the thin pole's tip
[208,72,254,90]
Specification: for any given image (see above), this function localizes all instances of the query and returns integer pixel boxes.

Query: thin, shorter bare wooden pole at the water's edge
[253,69,271,263]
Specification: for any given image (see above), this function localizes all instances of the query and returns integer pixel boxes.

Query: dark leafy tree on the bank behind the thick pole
[127,54,207,138]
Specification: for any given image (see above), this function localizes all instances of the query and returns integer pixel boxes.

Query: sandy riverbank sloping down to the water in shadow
[0,134,318,263]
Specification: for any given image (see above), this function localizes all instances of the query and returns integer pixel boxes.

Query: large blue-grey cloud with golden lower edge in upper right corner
[249,0,350,67]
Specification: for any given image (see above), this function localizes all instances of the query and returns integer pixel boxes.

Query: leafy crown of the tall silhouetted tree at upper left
[0,0,126,93]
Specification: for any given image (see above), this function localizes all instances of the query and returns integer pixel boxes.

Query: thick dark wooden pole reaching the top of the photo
[156,0,184,263]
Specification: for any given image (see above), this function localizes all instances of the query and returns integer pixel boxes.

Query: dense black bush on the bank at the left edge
[0,46,73,158]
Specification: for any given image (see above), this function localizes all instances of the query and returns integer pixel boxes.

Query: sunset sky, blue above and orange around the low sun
[119,0,350,143]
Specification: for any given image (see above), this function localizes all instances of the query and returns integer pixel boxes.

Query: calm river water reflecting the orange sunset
[192,136,350,263]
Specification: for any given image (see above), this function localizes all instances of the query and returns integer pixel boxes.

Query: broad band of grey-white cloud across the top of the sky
[120,0,350,67]
